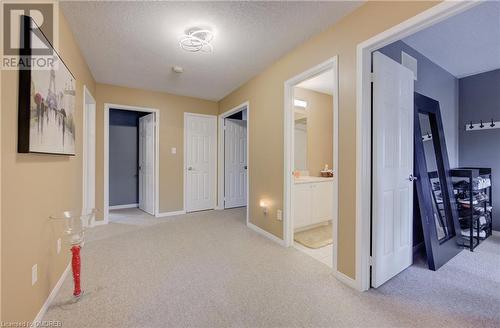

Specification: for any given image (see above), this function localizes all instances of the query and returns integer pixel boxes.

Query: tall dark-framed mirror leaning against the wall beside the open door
[414,93,461,270]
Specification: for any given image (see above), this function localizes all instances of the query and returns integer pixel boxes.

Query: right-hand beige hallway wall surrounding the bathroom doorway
[219,1,437,278]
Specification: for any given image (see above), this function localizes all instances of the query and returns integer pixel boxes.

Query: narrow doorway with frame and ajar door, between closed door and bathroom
[217,102,250,222]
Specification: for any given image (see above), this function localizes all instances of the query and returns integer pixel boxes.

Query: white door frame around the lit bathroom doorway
[283,56,344,272]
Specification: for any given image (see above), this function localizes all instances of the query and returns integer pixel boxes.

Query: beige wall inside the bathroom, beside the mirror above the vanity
[294,87,333,176]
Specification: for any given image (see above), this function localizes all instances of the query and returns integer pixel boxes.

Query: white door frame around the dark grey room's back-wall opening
[103,103,160,224]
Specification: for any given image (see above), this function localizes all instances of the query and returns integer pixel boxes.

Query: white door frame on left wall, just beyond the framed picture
[82,85,97,225]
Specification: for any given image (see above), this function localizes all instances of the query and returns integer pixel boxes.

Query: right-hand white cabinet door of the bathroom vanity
[311,182,333,224]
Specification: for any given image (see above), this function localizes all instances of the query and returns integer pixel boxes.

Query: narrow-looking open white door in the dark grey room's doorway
[139,114,156,215]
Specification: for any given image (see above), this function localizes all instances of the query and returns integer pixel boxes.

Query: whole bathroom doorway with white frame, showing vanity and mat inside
[283,57,343,272]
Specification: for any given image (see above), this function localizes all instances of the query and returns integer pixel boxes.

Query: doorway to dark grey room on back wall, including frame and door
[104,104,159,223]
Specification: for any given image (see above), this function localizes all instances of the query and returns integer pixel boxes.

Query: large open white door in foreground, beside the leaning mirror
[372,52,414,287]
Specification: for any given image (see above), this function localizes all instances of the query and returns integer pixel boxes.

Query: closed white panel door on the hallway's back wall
[184,113,217,212]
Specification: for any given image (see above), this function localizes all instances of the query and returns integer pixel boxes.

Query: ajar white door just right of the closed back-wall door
[224,118,248,208]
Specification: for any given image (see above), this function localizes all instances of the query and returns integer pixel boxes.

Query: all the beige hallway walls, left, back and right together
[0,2,442,321]
